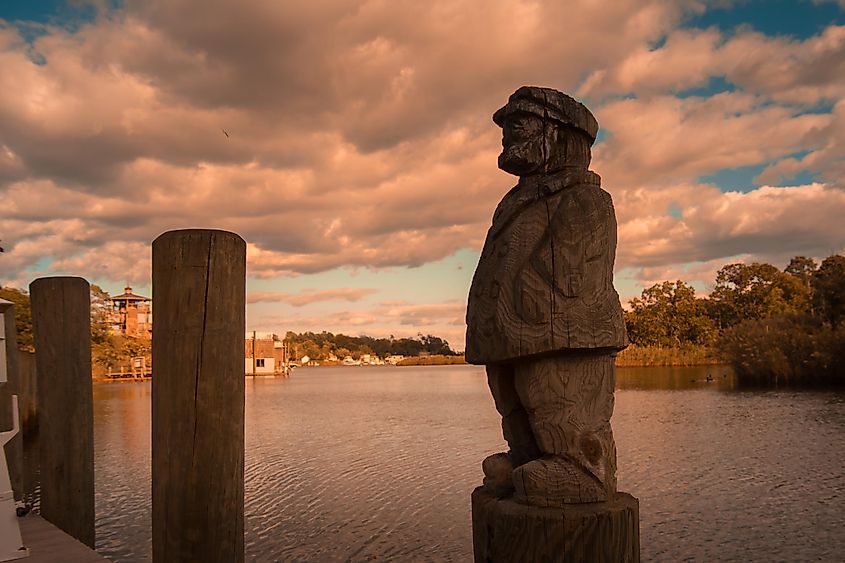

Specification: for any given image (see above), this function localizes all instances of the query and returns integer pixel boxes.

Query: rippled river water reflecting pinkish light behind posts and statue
[85,366,845,562]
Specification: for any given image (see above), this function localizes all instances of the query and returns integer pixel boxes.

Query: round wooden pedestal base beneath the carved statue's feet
[472,487,640,563]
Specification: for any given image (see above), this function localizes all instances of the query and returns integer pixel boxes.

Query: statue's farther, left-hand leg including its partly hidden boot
[482,365,541,488]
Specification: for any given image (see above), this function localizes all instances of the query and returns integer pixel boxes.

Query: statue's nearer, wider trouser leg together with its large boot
[514,354,616,506]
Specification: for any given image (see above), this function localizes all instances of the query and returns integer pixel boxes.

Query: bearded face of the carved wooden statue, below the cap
[499,113,545,176]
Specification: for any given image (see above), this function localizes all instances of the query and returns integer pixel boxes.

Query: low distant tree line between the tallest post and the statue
[284,331,457,360]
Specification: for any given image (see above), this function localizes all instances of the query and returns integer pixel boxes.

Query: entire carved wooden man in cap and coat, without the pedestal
[466,86,628,506]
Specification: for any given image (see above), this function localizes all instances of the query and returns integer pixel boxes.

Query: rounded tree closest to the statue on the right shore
[625,280,716,347]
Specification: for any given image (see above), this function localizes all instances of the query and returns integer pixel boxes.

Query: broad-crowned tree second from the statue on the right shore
[710,262,811,329]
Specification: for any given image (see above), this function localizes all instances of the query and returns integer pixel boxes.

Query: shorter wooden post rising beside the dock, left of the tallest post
[29,277,94,548]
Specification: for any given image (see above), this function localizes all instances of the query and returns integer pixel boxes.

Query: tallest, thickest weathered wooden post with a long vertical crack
[152,230,246,563]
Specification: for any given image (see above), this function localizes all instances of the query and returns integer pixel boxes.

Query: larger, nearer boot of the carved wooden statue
[513,456,608,507]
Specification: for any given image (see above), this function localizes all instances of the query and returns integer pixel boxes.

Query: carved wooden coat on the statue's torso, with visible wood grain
[466,170,628,364]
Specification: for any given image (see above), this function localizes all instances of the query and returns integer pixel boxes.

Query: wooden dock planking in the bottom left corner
[18,514,110,563]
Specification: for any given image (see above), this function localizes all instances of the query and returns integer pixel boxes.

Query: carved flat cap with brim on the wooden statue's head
[493,86,599,141]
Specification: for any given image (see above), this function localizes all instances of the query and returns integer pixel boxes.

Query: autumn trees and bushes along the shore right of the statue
[625,255,845,384]
